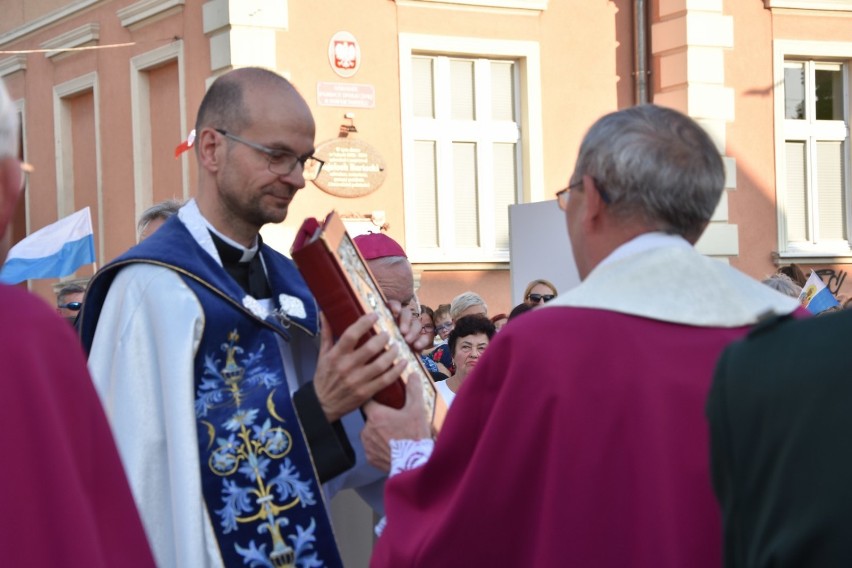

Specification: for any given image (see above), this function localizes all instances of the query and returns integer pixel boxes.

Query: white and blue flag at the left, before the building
[0,207,95,284]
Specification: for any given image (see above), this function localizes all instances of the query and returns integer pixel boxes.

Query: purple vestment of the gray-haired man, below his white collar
[372,307,748,568]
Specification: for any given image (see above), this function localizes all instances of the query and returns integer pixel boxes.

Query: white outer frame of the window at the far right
[773,40,852,260]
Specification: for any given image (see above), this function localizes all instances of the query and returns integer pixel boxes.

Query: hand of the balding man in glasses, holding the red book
[314,310,410,422]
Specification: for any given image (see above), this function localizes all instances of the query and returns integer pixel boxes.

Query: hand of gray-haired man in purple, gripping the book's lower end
[361,375,432,472]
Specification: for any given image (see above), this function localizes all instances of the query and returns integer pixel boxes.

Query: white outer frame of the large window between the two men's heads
[399,34,545,264]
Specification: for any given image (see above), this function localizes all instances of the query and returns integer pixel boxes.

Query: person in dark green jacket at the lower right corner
[707,311,852,568]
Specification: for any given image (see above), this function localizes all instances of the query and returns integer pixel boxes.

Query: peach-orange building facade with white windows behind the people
[0,0,852,565]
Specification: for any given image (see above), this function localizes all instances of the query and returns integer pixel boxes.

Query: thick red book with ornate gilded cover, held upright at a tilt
[291,212,446,431]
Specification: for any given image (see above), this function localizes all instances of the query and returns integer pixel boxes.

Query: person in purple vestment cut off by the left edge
[0,77,154,568]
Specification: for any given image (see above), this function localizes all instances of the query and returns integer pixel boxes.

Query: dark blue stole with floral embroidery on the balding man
[81,219,342,568]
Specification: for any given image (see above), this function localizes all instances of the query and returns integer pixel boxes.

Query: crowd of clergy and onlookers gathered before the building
[0,68,852,568]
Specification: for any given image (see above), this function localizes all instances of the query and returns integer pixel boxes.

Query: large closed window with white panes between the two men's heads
[401,36,539,263]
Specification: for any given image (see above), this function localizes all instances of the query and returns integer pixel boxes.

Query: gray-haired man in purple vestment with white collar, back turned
[362,105,798,568]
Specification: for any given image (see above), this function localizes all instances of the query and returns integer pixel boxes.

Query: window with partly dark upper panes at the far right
[776,46,852,256]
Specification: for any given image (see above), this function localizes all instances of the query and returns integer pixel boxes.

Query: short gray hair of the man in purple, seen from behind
[571,105,725,243]
